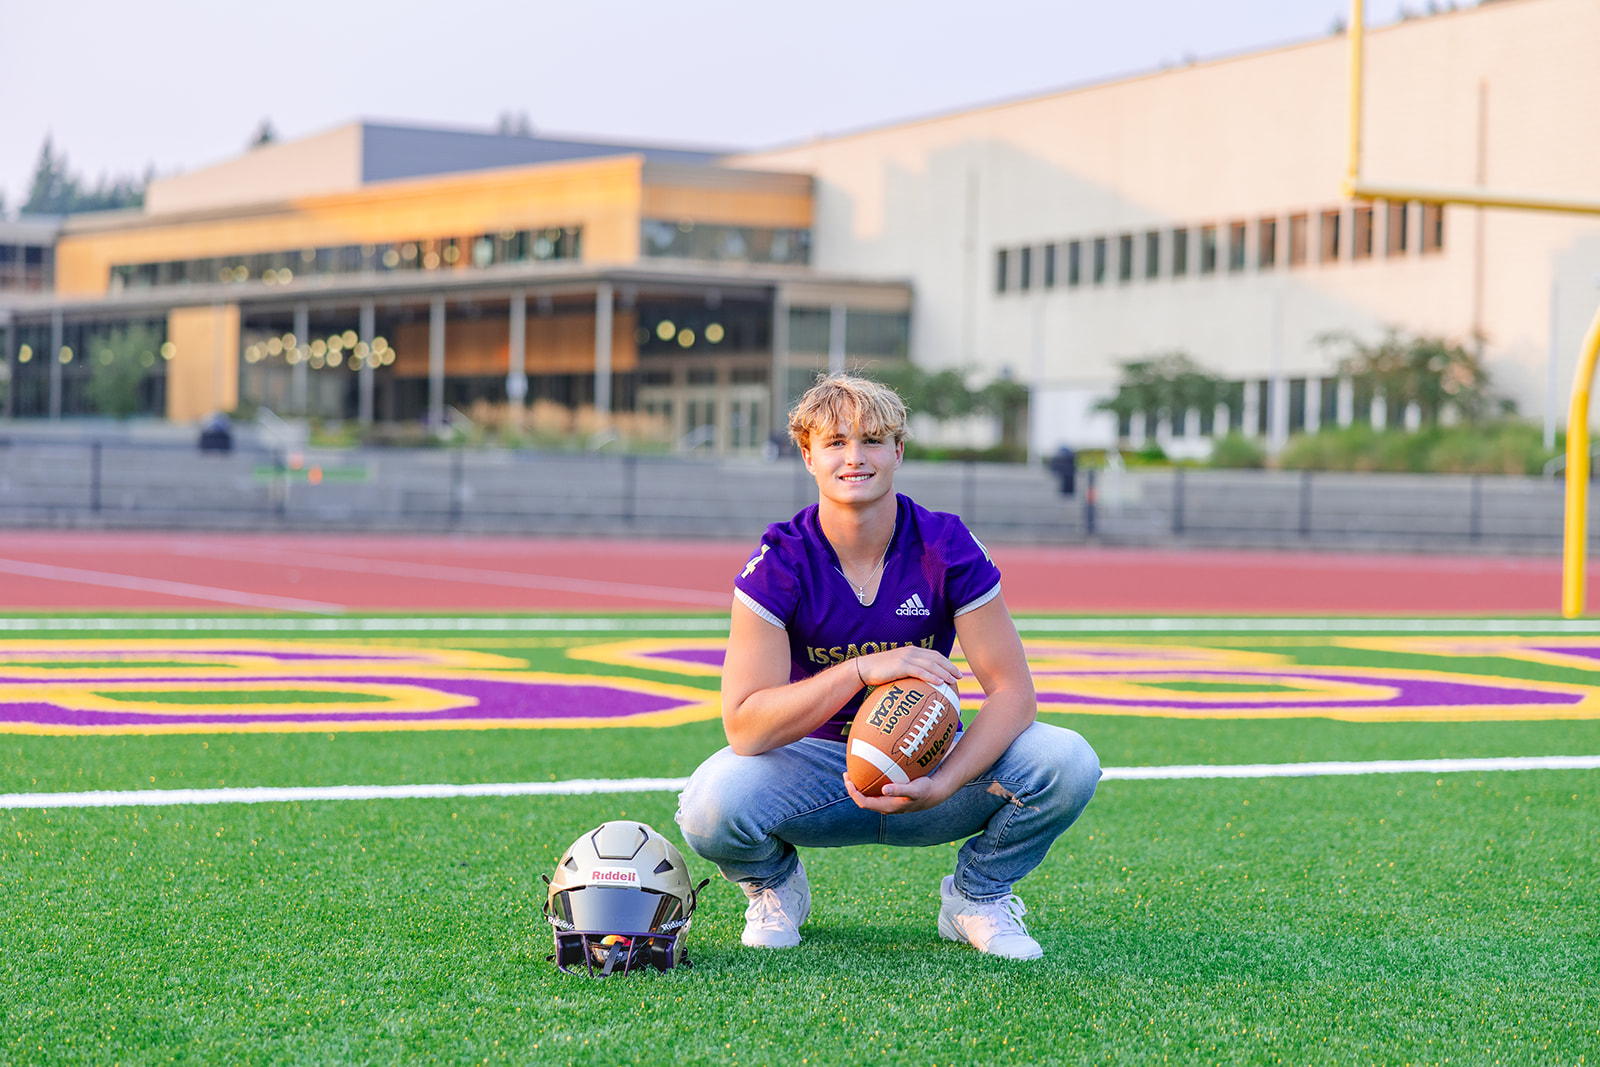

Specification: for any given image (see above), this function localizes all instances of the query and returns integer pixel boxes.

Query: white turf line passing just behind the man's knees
[0,755,1600,809]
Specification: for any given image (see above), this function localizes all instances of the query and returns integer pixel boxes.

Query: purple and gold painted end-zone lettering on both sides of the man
[0,637,1600,734]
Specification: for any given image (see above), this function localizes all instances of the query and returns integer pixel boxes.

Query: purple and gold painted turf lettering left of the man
[0,640,720,734]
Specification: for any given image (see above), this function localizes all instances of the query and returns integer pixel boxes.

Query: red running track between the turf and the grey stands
[0,531,1561,616]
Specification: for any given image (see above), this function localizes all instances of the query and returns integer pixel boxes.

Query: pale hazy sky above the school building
[0,0,1466,214]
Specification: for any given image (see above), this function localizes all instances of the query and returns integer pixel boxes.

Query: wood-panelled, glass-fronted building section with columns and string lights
[0,130,910,453]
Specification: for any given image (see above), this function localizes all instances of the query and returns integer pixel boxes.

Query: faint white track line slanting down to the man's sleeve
[171,541,733,608]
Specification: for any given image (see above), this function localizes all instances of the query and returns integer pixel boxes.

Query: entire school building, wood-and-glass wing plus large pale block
[0,0,1600,454]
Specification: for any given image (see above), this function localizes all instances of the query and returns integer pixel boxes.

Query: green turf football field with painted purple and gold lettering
[0,619,1600,1064]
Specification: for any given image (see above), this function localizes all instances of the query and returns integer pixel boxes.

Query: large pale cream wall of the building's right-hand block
[730,0,1600,451]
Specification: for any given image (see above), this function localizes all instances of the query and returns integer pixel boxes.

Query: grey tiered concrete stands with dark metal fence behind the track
[0,438,1574,553]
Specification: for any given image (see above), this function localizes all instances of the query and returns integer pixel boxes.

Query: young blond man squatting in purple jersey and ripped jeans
[677,374,1099,960]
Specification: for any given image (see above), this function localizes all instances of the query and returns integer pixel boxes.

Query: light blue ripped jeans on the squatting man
[677,723,1101,901]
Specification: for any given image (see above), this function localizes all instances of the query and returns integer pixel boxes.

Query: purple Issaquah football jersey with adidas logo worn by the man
[733,496,1000,741]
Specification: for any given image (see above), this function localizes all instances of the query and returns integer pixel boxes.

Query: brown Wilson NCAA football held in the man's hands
[845,678,962,797]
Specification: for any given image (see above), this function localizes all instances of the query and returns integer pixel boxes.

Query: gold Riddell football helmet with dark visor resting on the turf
[544,819,710,977]
